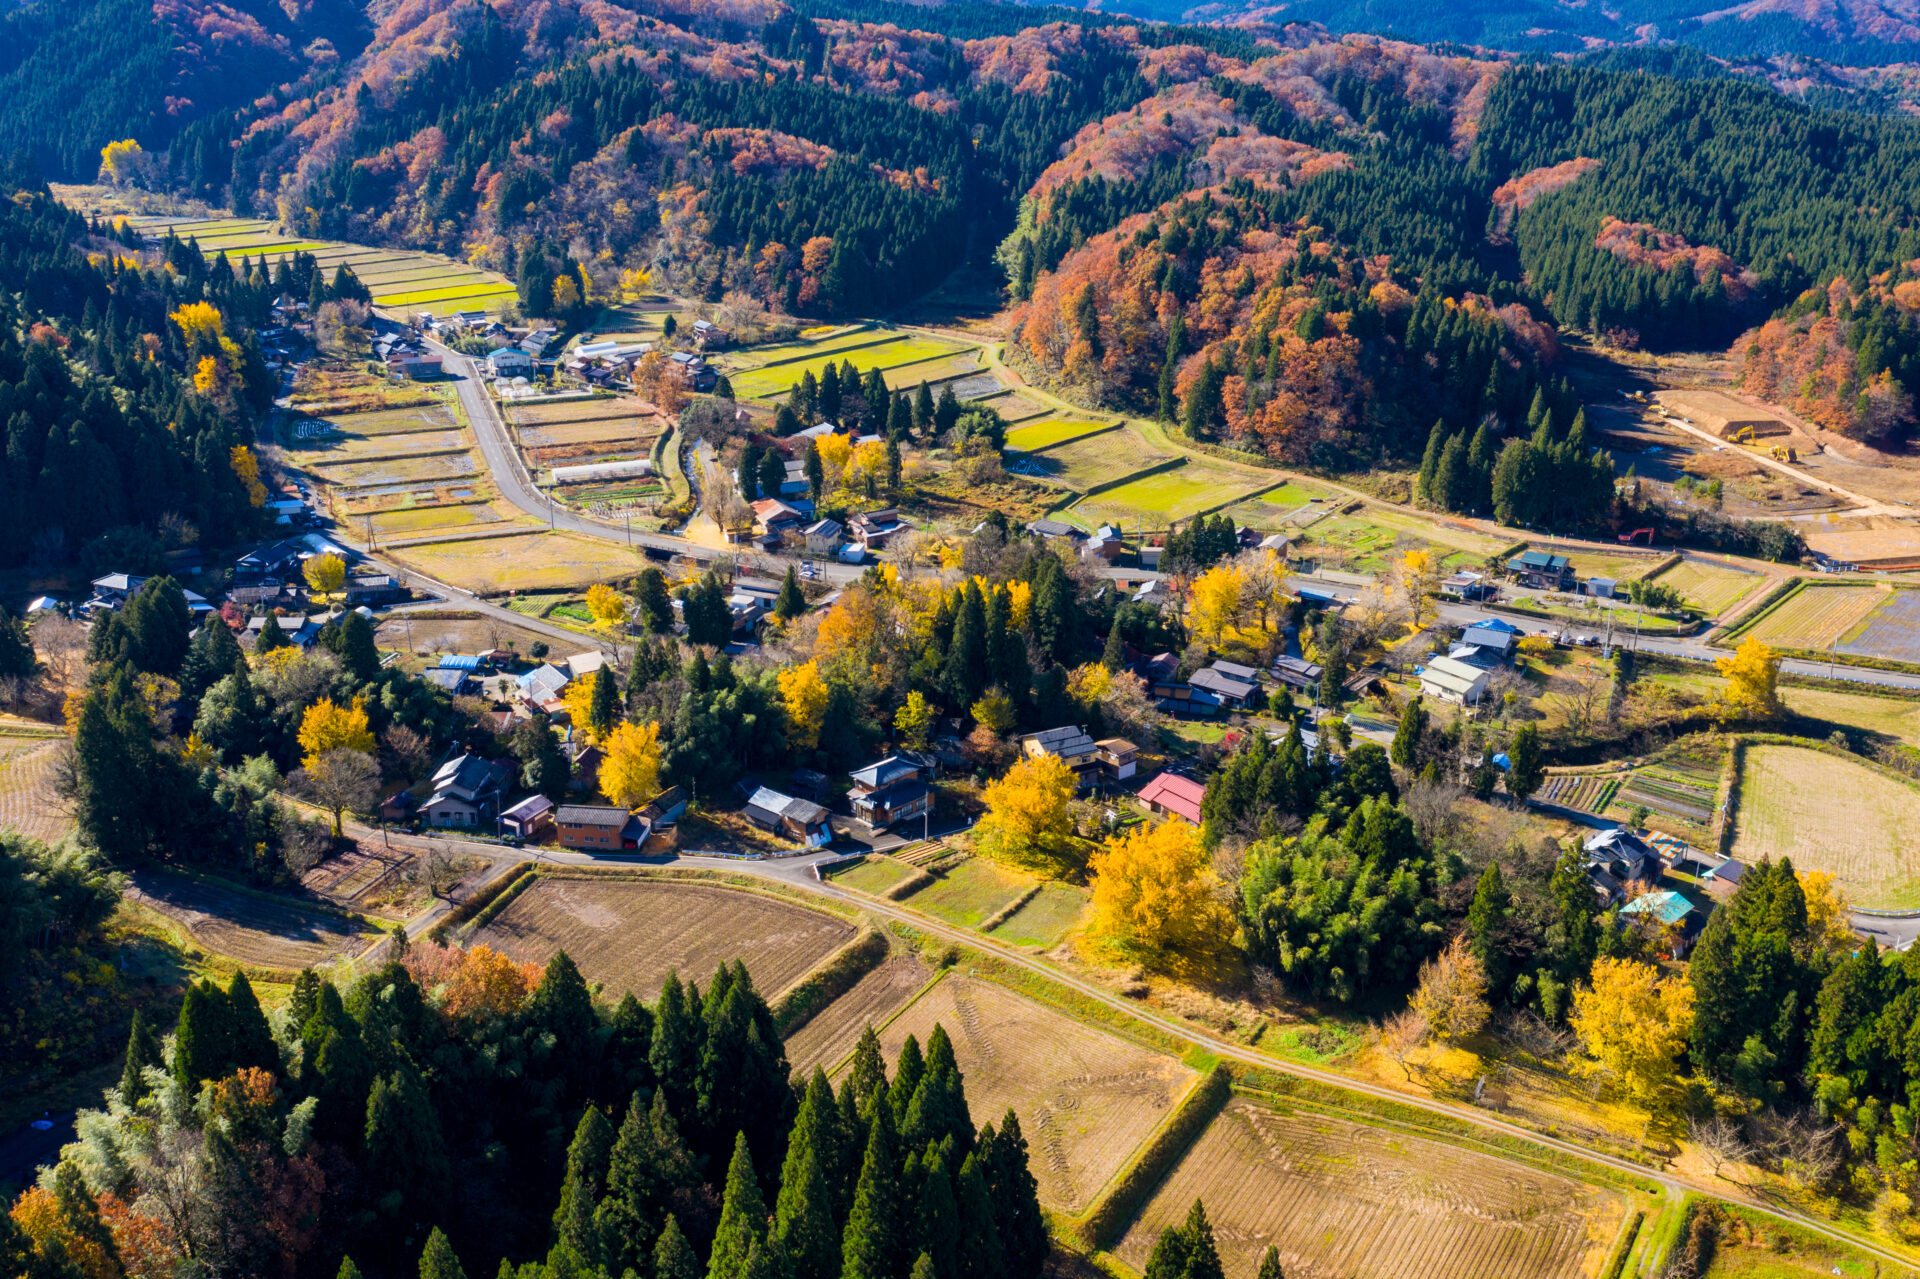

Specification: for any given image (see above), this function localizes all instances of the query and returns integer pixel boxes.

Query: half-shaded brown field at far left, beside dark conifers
[127,870,367,968]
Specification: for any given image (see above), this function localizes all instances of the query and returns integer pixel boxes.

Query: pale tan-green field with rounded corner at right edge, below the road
[1734,745,1920,910]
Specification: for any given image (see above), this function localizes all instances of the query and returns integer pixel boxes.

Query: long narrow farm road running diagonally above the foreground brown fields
[393,845,1912,1267]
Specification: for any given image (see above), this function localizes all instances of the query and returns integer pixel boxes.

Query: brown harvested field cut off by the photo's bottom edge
[1116,1098,1626,1279]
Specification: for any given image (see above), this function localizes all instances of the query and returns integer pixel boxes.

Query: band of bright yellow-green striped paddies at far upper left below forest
[129,217,516,311]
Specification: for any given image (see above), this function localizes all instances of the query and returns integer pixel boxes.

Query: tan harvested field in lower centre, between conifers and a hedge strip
[879,972,1194,1212]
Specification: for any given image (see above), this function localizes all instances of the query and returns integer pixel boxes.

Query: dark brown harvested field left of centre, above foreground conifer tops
[474,878,854,1001]
